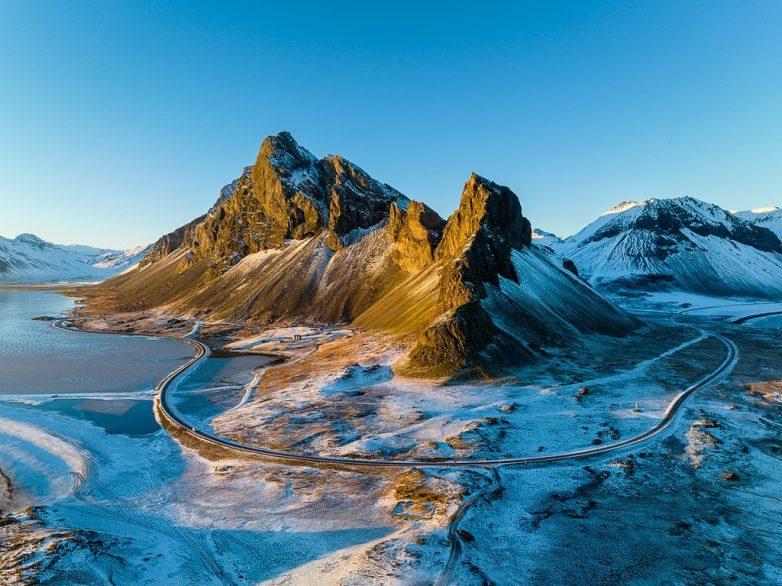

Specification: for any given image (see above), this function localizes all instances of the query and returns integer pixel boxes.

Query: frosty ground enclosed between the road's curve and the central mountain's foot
[213,320,724,459]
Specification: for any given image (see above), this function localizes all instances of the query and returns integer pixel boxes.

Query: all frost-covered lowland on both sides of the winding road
[0,296,782,584]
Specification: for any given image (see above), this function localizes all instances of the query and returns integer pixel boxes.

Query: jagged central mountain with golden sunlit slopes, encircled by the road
[92,132,639,376]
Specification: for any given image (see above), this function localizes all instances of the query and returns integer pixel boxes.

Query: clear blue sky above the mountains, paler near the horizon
[0,0,782,247]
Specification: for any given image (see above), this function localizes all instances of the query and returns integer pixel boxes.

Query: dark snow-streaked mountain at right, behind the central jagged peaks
[555,197,782,298]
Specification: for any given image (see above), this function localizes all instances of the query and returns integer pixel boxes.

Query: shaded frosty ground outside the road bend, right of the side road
[459,300,782,585]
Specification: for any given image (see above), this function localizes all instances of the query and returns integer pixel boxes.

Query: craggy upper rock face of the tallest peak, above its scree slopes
[144,132,407,278]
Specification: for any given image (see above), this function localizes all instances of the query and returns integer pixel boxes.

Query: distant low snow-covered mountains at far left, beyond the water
[0,234,149,284]
